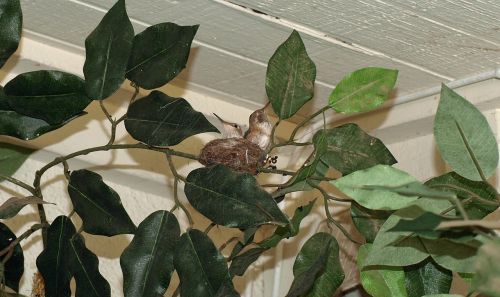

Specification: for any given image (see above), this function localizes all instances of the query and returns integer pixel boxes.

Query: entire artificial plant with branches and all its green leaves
[0,0,500,297]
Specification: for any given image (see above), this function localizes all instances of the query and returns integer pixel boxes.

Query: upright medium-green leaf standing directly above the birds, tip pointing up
[266,30,316,120]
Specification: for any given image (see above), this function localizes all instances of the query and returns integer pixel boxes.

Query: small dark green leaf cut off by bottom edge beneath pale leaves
[404,258,453,297]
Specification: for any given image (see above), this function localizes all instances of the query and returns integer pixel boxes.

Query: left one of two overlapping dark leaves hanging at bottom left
[36,216,76,297]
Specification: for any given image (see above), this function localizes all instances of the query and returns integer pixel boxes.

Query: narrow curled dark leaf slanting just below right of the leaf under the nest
[259,199,316,248]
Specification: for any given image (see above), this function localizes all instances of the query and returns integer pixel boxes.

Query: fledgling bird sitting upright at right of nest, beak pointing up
[244,102,273,152]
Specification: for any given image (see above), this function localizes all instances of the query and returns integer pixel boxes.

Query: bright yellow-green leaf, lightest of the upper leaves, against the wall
[329,67,398,114]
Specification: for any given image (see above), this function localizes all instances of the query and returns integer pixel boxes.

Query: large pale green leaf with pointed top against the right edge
[434,85,498,180]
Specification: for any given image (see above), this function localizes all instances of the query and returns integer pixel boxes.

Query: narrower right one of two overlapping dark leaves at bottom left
[70,234,111,297]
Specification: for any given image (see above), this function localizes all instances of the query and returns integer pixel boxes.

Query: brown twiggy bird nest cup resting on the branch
[199,138,264,175]
